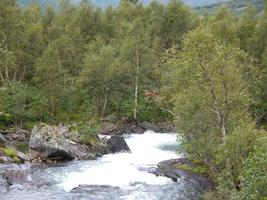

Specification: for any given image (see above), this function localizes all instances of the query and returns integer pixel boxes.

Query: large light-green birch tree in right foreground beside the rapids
[169,28,253,159]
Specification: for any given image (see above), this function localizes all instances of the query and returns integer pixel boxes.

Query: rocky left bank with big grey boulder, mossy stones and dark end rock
[0,124,130,164]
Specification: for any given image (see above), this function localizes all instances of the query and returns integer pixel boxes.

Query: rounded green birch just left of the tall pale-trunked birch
[79,37,120,117]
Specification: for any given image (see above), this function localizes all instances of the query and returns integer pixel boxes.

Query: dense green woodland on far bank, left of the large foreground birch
[0,0,197,124]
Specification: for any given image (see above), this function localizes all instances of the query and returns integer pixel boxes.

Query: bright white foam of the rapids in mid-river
[60,131,177,191]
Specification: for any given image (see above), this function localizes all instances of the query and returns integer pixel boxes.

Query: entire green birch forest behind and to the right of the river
[0,0,267,200]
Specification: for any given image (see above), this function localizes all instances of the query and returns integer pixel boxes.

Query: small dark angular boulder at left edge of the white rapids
[107,136,131,153]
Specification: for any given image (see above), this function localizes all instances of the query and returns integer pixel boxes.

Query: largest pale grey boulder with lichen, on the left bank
[29,125,95,161]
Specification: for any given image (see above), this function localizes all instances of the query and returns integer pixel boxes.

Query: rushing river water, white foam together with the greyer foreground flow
[0,132,204,200]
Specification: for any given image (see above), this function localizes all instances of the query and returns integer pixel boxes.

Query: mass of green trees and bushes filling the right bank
[163,3,267,200]
